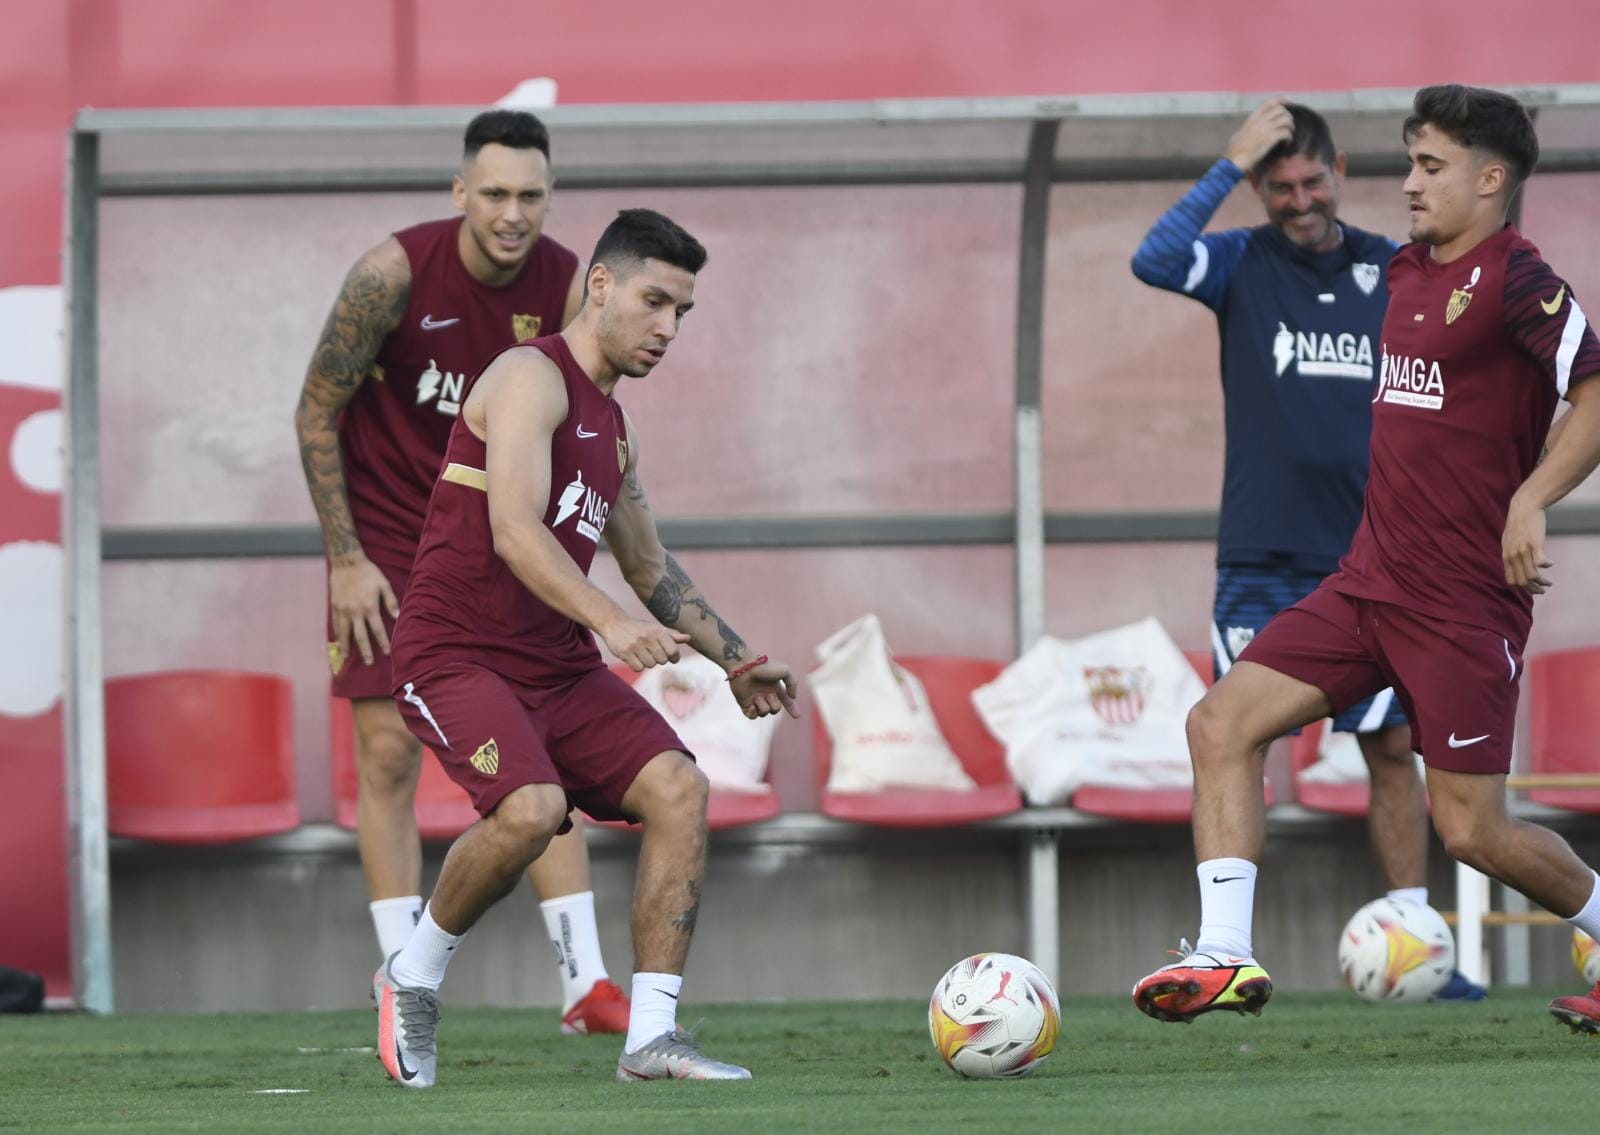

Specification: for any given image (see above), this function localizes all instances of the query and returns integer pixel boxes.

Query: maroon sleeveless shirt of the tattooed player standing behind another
[339,218,578,580]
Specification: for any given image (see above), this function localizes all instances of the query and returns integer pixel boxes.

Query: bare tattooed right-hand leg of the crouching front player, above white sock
[622,752,707,973]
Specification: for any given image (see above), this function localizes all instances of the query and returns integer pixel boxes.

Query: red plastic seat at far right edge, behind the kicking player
[1528,647,1600,812]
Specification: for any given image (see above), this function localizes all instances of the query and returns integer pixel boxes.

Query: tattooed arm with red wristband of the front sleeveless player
[605,426,800,717]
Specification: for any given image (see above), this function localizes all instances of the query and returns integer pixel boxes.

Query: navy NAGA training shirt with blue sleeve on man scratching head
[1133,158,1398,573]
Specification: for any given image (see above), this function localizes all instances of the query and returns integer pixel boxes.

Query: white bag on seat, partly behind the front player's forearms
[634,650,778,792]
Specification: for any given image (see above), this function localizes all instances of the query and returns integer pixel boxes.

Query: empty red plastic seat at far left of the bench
[106,671,299,844]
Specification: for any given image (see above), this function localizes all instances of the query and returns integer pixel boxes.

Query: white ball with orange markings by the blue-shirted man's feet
[1339,898,1456,1001]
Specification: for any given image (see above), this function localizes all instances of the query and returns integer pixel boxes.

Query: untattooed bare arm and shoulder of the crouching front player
[480,347,688,671]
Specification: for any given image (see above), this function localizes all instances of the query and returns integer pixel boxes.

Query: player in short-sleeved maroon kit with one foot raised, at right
[1133,86,1600,1033]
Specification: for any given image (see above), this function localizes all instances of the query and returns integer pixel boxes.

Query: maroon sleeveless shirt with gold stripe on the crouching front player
[394,335,627,688]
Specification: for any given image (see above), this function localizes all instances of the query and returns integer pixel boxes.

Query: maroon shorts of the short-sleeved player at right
[1238,583,1522,773]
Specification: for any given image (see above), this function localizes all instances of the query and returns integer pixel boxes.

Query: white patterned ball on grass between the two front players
[928,954,1061,1081]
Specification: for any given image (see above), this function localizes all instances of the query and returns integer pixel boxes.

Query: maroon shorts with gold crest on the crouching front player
[394,663,693,820]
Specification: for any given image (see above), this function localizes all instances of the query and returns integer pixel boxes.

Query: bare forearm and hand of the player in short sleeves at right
[1501,375,1600,596]
